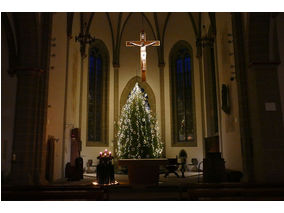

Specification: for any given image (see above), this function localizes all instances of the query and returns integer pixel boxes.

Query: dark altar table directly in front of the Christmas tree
[118,158,168,185]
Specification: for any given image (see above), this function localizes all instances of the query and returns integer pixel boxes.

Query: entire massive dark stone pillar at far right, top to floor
[232,13,284,182]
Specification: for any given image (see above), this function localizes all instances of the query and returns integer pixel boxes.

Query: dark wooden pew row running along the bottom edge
[2,183,284,201]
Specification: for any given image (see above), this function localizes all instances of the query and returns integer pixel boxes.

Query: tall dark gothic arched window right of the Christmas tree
[170,41,197,146]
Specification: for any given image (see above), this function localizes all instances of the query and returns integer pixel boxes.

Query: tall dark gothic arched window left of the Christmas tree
[87,40,109,146]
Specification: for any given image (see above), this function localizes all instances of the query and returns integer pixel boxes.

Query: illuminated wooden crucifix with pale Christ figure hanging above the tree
[126,31,160,81]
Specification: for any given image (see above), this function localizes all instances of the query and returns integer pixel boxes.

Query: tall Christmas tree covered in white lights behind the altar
[117,83,164,159]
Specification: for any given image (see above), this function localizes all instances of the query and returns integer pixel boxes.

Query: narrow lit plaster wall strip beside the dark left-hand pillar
[46,13,67,179]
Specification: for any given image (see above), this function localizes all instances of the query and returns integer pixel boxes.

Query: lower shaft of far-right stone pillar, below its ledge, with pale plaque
[247,62,284,182]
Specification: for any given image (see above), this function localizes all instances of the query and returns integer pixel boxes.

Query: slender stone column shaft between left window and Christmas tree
[113,64,119,156]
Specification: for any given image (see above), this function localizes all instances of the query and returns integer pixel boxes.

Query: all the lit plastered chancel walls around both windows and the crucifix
[47,13,242,178]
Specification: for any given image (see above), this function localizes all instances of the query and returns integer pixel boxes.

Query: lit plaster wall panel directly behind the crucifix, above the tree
[119,13,161,141]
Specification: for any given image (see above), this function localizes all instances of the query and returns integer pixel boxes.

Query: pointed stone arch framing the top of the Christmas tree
[120,76,156,114]
